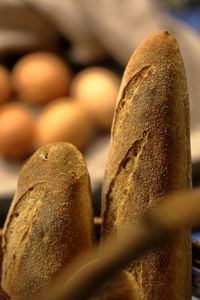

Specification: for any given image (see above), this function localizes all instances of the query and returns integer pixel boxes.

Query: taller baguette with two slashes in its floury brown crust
[102,31,191,300]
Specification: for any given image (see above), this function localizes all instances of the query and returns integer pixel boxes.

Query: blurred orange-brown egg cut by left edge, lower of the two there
[0,103,34,159]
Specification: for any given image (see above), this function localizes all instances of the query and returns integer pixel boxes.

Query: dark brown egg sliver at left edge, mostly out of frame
[0,65,11,104]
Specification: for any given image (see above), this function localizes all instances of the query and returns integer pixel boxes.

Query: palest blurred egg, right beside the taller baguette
[71,67,120,129]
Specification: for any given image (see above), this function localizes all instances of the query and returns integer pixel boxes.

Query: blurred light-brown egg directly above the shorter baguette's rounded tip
[36,98,93,150]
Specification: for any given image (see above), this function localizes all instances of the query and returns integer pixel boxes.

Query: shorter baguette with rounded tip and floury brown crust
[2,143,94,300]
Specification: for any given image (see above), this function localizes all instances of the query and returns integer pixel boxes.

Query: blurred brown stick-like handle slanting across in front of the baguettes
[41,189,200,300]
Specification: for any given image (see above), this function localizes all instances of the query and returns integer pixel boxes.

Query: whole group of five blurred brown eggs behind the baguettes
[0,52,119,159]
